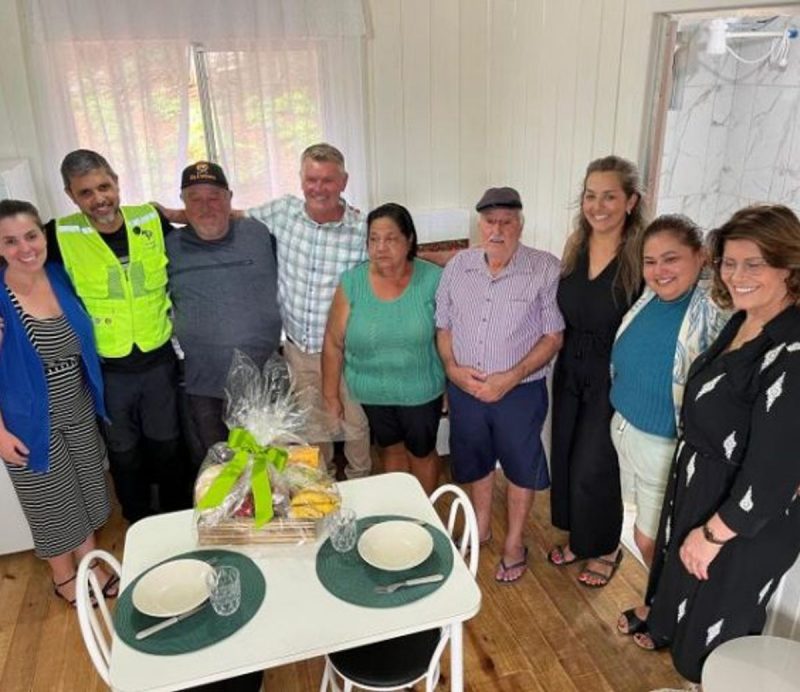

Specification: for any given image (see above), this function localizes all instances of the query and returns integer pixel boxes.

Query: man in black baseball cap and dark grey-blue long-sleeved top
[166,161,281,465]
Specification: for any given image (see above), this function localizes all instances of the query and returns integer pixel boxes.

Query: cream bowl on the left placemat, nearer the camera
[132,560,214,617]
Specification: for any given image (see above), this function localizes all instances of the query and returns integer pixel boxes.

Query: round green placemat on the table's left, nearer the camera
[114,550,267,655]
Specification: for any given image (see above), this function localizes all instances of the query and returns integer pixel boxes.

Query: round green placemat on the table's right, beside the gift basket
[317,515,453,608]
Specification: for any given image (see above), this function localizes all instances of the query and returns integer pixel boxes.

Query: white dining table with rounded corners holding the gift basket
[110,473,481,692]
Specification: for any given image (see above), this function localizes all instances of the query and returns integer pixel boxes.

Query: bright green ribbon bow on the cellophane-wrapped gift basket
[197,428,289,528]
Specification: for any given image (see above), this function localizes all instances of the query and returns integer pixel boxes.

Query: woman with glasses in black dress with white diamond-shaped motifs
[620,205,800,682]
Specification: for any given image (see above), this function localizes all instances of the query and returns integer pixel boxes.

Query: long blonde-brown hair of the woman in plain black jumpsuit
[561,156,647,302]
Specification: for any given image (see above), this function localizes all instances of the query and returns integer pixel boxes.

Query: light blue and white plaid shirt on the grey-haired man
[247,195,367,353]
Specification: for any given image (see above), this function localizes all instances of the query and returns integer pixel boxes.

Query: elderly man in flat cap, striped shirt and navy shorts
[436,187,564,583]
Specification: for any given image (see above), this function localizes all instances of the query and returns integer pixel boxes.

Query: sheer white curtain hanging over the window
[25,0,368,213]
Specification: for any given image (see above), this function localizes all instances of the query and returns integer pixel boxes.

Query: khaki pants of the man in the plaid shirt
[283,341,372,478]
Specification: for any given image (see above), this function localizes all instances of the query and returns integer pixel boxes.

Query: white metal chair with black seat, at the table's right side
[320,485,480,692]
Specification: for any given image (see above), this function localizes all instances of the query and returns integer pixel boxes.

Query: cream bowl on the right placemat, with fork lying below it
[358,520,433,572]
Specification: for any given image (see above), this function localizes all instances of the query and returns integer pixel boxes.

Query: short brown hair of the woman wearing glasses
[708,204,800,308]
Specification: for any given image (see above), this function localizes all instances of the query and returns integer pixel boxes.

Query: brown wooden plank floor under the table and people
[0,464,684,692]
